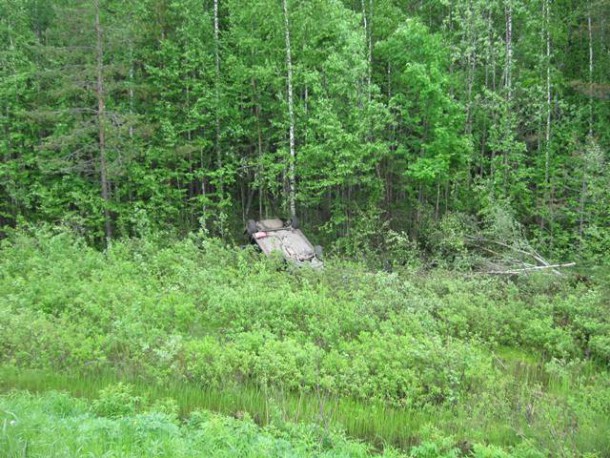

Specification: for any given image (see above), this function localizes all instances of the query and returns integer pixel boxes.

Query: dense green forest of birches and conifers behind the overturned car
[0,0,610,261]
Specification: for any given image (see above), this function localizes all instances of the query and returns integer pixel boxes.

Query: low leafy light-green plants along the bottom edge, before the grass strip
[0,383,576,458]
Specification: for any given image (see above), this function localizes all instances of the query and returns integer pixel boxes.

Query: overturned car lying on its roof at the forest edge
[246,218,323,268]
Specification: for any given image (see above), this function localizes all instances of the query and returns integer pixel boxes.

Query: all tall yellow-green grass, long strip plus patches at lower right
[0,364,610,453]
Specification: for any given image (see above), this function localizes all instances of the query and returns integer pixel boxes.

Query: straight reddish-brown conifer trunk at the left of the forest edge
[93,0,112,246]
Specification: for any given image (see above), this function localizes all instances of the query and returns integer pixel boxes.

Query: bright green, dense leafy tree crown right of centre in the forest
[377,20,470,183]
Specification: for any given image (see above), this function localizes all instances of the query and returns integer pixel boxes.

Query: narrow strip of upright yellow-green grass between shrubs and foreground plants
[0,367,442,448]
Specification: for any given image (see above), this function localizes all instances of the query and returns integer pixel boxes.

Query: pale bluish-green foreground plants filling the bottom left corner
[0,392,382,458]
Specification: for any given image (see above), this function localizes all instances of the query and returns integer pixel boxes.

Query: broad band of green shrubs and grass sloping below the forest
[0,229,610,454]
